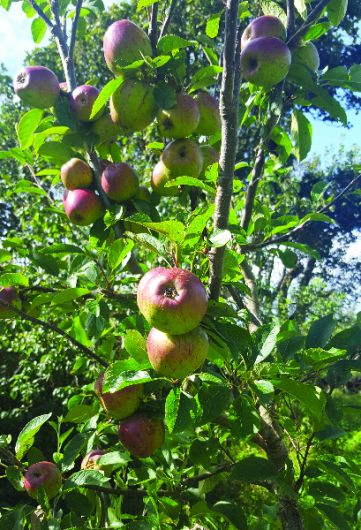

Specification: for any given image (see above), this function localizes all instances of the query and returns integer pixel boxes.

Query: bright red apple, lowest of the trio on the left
[63,189,104,226]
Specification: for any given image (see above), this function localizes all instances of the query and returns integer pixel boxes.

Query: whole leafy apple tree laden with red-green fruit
[0,0,361,530]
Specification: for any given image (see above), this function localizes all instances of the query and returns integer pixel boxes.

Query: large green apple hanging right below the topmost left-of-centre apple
[110,79,157,132]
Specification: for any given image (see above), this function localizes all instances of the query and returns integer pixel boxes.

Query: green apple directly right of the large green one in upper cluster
[157,93,200,138]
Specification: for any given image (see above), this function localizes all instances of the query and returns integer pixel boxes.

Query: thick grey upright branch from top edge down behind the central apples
[209,0,239,300]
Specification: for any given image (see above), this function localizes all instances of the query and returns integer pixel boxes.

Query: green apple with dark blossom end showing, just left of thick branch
[161,138,203,180]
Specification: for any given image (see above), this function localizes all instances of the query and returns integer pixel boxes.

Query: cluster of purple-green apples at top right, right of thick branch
[240,15,320,88]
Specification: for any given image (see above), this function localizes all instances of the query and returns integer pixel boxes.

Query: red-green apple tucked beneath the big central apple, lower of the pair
[147,327,209,379]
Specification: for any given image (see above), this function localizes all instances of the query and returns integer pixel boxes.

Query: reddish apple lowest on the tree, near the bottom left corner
[24,462,62,499]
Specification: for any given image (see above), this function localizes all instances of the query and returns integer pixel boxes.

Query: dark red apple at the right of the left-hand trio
[101,162,139,202]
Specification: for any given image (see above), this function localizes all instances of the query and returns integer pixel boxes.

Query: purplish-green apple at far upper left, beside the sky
[14,66,60,109]
